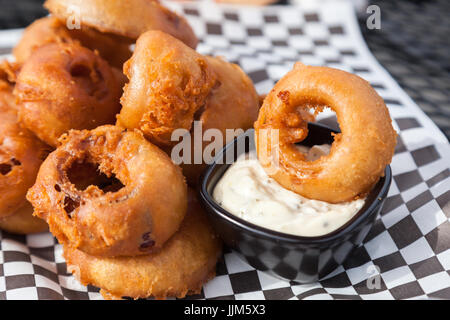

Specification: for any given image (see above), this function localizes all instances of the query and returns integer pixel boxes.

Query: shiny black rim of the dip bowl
[198,123,392,245]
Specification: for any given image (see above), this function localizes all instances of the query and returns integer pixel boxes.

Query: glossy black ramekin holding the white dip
[199,124,392,283]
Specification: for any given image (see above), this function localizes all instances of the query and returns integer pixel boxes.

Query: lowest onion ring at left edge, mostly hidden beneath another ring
[0,201,48,234]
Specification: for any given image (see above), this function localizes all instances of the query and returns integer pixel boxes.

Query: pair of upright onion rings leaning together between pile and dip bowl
[117,31,259,184]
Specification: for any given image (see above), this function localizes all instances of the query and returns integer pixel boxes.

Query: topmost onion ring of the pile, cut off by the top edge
[44,0,198,48]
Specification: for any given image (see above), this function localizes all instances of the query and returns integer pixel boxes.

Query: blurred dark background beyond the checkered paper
[0,0,450,139]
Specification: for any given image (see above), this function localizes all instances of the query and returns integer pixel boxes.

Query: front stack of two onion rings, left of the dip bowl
[27,126,221,299]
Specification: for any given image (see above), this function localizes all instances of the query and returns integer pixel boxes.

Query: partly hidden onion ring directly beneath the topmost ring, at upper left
[13,16,131,69]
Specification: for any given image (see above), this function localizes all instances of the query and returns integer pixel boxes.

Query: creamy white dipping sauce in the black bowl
[213,145,365,237]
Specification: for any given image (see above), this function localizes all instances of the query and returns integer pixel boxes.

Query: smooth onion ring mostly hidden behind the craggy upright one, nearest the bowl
[181,57,259,185]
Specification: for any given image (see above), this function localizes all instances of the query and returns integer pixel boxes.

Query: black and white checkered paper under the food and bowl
[0,1,450,300]
